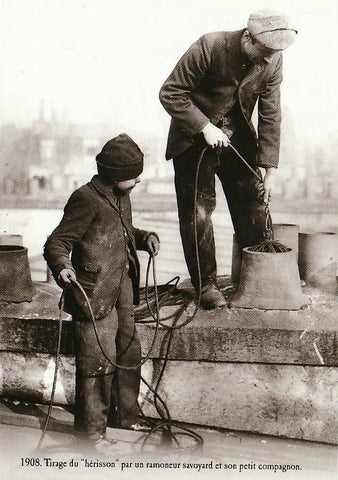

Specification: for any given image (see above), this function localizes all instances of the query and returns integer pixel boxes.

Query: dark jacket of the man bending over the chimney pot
[160,30,283,167]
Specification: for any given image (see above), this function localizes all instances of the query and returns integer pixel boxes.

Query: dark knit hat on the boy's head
[96,133,143,182]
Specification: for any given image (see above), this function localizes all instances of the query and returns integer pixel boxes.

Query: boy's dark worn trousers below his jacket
[73,269,141,440]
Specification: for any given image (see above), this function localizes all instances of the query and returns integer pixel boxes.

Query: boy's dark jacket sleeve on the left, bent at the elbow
[43,190,95,278]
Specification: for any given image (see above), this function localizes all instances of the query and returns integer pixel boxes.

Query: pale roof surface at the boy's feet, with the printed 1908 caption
[0,403,337,480]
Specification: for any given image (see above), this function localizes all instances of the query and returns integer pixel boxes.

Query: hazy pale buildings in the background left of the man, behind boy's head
[0,102,168,202]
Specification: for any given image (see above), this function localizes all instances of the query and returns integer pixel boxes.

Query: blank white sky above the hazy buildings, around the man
[0,0,338,144]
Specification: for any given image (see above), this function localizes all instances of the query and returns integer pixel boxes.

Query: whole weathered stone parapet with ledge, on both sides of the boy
[0,282,338,443]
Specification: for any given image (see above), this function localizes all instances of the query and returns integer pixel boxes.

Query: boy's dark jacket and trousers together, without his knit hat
[44,175,156,435]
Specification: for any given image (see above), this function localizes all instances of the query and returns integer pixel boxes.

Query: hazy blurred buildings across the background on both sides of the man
[0,101,338,206]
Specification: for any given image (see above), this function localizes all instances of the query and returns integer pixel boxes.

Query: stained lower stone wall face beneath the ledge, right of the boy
[143,361,338,443]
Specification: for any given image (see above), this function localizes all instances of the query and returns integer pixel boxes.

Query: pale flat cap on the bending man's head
[247,9,297,50]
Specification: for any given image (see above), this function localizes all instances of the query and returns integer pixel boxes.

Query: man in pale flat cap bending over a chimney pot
[160,11,297,308]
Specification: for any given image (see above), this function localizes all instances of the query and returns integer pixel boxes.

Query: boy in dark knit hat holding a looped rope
[44,133,159,445]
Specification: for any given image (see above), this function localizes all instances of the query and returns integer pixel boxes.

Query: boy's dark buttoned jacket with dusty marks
[44,175,150,319]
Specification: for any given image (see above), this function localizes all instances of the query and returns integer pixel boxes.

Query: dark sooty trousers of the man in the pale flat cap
[174,129,266,288]
